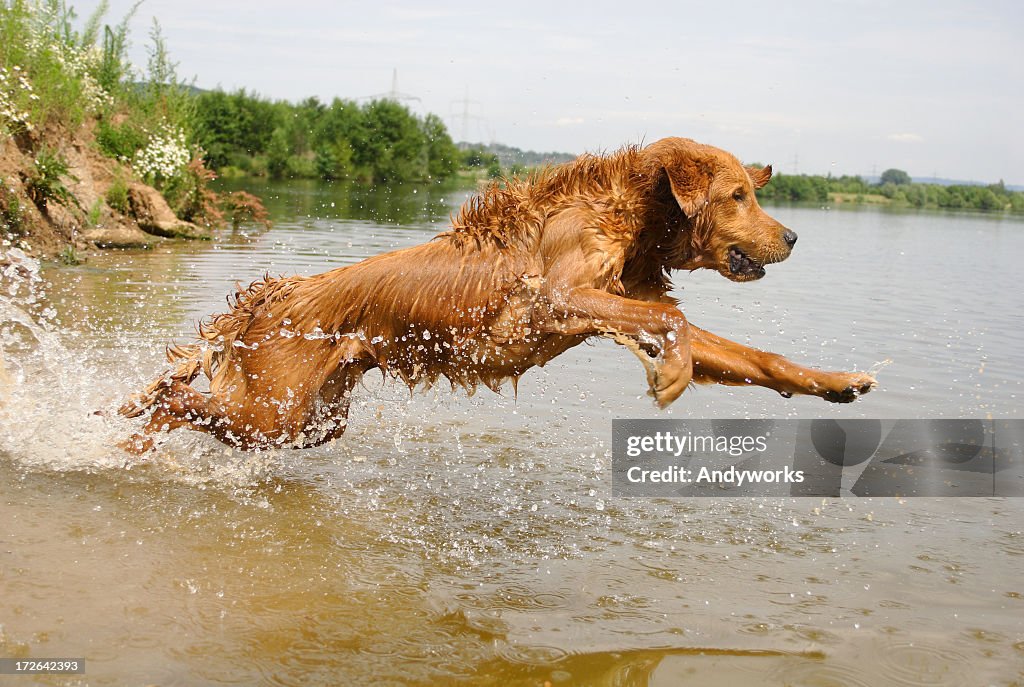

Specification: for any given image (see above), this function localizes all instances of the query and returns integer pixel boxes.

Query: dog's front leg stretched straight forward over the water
[690,325,876,403]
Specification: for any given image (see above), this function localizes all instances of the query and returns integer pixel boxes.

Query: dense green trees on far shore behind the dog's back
[194,90,461,182]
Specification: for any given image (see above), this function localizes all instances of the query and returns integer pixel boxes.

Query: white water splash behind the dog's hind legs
[0,249,274,487]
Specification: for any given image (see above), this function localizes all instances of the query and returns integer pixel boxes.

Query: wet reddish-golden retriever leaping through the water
[120,138,876,453]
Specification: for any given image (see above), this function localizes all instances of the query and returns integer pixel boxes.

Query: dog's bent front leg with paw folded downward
[542,288,693,407]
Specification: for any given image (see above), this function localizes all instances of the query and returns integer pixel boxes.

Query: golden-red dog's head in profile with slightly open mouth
[642,138,797,282]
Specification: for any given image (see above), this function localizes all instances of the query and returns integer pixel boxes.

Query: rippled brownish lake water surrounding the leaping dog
[0,183,1024,686]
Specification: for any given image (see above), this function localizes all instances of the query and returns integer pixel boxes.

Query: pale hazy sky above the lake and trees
[83,0,1024,184]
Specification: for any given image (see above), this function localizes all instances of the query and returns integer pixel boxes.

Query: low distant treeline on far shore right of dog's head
[758,170,1024,212]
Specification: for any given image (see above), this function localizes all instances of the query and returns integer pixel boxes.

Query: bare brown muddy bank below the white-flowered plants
[0,123,210,258]
